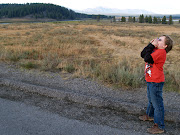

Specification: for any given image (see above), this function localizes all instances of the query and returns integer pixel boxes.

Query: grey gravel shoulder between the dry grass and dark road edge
[0,63,180,123]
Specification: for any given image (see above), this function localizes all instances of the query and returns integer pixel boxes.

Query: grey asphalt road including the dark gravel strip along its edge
[0,86,179,135]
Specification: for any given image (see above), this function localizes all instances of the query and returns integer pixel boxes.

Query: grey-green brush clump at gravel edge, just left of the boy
[96,60,143,88]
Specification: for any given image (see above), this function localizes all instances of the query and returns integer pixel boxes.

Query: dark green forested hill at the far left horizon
[0,3,108,20]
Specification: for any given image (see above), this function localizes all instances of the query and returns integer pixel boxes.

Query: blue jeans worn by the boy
[146,82,164,129]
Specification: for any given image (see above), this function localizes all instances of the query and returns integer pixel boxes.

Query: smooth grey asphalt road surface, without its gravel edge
[0,98,141,135]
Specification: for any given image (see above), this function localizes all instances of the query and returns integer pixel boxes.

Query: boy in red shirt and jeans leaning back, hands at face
[139,35,173,134]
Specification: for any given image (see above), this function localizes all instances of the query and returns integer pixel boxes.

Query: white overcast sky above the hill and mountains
[0,0,180,14]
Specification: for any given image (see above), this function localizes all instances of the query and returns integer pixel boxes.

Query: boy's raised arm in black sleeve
[141,43,155,64]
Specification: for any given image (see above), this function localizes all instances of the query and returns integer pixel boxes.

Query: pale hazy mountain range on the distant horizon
[76,7,155,15]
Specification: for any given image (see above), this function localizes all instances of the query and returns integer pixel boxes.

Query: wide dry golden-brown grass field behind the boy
[0,21,180,92]
